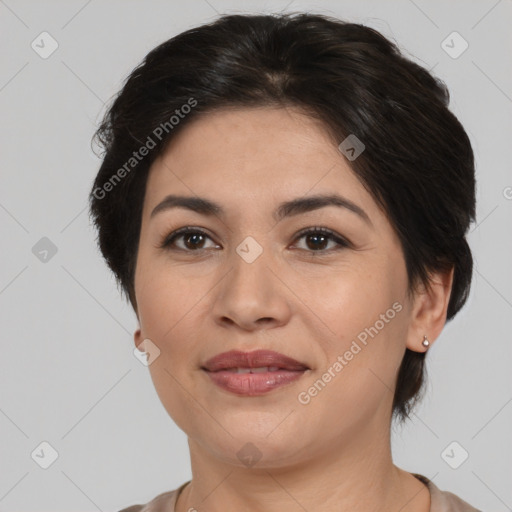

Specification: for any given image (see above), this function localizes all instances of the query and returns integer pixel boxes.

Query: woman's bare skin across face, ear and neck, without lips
[134,108,452,512]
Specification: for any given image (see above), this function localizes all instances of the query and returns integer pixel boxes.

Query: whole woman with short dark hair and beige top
[90,14,477,512]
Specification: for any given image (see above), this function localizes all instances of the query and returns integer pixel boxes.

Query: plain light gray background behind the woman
[0,0,512,512]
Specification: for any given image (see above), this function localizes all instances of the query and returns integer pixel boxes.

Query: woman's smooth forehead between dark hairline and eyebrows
[145,108,377,220]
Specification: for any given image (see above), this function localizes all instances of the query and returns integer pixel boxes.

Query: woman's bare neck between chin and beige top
[176,416,430,512]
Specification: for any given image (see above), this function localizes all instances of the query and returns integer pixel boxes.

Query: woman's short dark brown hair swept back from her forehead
[89,13,475,422]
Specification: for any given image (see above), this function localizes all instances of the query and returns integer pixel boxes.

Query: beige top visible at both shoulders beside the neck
[119,473,482,512]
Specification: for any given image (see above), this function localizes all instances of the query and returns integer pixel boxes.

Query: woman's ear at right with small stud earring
[407,267,454,352]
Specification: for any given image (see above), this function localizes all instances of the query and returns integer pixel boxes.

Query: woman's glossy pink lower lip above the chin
[206,370,306,396]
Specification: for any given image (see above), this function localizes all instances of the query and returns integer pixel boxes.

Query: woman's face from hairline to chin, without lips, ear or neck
[135,108,422,467]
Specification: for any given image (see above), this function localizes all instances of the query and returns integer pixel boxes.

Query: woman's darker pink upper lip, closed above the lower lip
[202,350,309,372]
